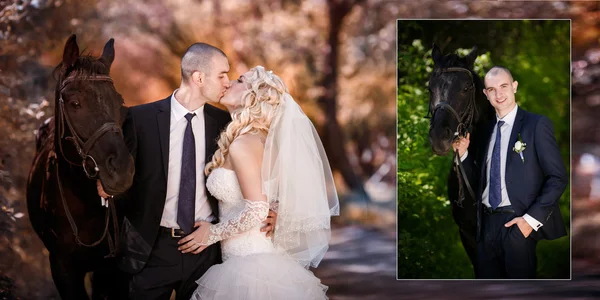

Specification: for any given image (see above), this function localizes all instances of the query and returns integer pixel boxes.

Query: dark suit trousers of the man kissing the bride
[129,233,221,300]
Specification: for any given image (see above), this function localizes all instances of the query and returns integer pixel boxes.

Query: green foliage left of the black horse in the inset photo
[398,40,489,278]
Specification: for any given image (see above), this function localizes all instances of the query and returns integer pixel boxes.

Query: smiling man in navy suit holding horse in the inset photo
[454,67,568,278]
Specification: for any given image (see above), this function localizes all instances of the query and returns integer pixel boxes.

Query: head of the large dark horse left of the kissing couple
[54,35,135,195]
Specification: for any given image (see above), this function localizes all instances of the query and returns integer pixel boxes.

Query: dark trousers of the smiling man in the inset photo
[475,213,537,279]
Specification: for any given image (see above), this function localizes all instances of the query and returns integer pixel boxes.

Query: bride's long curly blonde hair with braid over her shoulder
[204,66,288,175]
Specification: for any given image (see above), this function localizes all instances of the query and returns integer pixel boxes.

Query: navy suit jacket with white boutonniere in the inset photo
[463,107,568,240]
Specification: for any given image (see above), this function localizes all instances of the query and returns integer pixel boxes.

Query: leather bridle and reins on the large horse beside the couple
[47,75,123,257]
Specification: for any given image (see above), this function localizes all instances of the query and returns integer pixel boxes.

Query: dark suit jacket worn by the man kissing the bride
[118,96,231,274]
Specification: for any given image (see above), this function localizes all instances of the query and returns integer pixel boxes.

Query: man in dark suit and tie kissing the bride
[99,43,273,300]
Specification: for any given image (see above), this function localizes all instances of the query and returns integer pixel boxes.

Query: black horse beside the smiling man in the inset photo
[429,44,494,265]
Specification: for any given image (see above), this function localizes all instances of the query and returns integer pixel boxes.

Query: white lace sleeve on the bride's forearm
[202,199,269,245]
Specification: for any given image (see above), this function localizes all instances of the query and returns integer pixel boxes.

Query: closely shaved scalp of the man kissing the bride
[181,43,227,81]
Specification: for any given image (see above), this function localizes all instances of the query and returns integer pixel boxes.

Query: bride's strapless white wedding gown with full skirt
[192,168,327,300]
